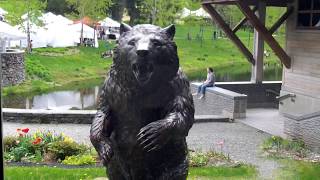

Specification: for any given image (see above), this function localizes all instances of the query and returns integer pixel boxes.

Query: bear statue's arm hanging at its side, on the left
[90,83,112,163]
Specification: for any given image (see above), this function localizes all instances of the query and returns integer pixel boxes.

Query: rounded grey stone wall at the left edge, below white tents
[0,51,25,86]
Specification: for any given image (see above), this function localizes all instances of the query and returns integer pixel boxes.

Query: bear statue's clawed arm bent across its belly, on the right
[137,74,194,152]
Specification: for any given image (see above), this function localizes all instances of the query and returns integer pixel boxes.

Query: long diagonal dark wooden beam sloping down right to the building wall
[238,0,291,68]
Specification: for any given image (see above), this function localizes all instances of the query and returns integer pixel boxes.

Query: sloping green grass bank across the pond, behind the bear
[3,25,284,96]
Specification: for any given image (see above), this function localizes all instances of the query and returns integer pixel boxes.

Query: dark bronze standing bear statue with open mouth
[90,24,194,180]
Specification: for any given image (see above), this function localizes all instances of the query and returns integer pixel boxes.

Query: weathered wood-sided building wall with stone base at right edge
[280,0,320,151]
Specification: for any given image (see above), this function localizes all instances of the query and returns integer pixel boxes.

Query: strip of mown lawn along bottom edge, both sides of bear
[5,166,256,180]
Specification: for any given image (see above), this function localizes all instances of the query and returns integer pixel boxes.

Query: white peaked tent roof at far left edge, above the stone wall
[0,21,27,40]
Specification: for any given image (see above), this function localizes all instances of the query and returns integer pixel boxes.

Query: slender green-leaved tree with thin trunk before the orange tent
[66,0,112,44]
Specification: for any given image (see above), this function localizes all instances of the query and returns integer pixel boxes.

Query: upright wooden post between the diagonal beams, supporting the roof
[251,1,266,84]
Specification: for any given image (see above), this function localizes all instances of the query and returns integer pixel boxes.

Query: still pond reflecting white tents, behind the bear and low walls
[3,66,282,110]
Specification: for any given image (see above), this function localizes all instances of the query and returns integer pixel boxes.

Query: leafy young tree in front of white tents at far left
[6,0,46,53]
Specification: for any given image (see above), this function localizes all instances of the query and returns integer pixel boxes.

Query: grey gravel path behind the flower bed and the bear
[3,122,279,179]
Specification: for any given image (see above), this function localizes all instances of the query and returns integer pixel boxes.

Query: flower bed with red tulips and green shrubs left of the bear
[4,128,100,165]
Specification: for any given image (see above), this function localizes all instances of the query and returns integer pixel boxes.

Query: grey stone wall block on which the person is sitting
[191,83,247,119]
